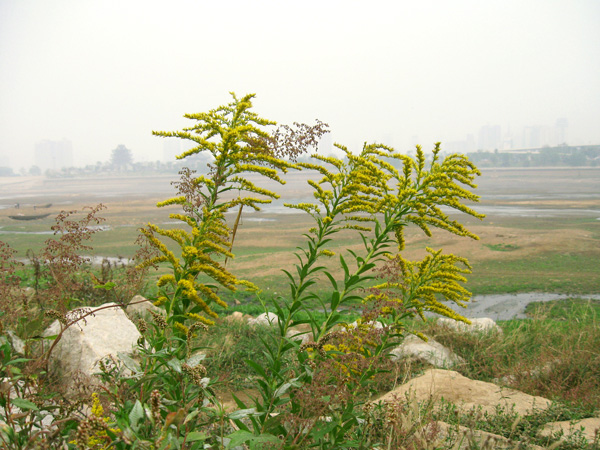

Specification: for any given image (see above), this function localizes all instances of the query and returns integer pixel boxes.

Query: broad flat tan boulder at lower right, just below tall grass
[377,369,552,416]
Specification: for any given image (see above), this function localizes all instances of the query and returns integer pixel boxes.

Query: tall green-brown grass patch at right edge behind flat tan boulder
[426,298,600,417]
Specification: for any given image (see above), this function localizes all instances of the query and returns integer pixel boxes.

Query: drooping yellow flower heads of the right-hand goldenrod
[286,143,483,336]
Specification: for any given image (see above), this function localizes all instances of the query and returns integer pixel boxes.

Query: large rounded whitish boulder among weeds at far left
[44,303,141,391]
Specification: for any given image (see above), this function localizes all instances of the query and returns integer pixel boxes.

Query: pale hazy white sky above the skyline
[0,0,600,167]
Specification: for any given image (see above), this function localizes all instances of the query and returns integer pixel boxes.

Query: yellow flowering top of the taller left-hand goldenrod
[142,94,312,328]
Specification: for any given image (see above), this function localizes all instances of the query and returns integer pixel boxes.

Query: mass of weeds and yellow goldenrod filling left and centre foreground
[0,95,596,450]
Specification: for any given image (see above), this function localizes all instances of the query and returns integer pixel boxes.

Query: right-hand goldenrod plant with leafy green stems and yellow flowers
[224,144,483,448]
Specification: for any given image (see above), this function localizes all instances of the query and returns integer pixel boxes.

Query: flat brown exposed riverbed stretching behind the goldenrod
[0,168,600,294]
